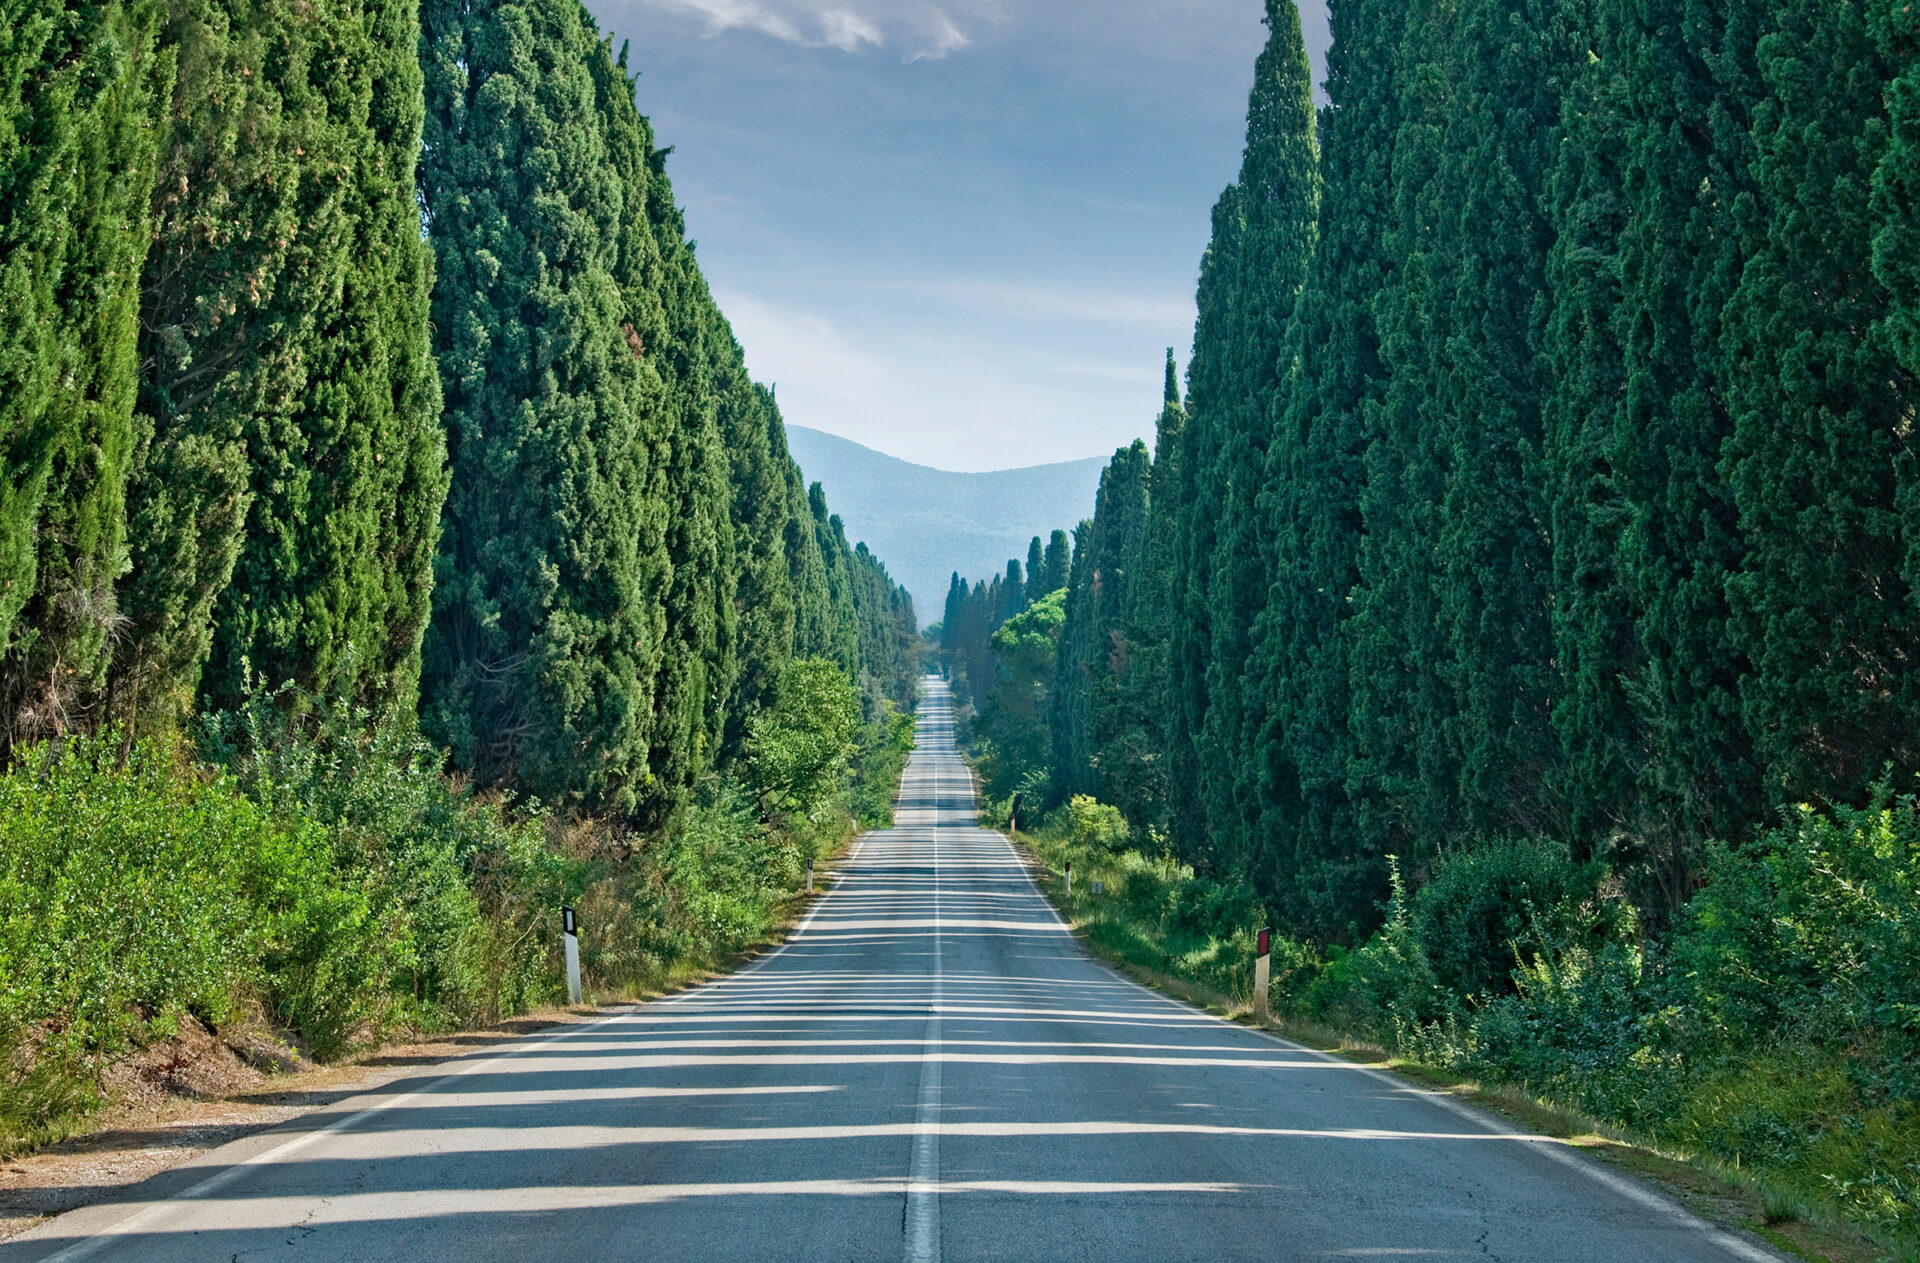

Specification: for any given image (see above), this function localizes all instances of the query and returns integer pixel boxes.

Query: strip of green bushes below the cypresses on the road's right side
[983,793,1920,1259]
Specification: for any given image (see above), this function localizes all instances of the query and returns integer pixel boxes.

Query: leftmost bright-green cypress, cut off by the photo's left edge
[0,0,171,749]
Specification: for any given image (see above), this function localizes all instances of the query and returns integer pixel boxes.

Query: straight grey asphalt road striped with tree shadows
[11,681,1778,1263]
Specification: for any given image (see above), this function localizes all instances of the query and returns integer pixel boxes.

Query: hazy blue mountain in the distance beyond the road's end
[787,424,1108,628]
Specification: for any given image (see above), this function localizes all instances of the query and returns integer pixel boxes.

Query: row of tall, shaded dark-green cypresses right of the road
[1054,0,1920,939]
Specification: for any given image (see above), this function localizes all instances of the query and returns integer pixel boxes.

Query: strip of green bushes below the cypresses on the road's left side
[0,660,912,1154]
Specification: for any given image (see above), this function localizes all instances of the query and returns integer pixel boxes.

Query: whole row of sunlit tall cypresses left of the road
[0,0,916,822]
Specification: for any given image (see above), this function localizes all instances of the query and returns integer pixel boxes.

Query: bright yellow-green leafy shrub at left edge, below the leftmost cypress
[0,731,314,1061]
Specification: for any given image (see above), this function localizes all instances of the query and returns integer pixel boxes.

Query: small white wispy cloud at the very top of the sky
[641,0,972,61]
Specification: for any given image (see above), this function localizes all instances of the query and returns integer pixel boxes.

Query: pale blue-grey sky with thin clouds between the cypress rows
[588,0,1327,470]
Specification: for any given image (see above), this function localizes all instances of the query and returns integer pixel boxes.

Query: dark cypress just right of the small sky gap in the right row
[1244,0,1404,939]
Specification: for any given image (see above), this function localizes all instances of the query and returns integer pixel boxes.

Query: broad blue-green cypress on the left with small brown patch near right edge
[420,0,668,810]
